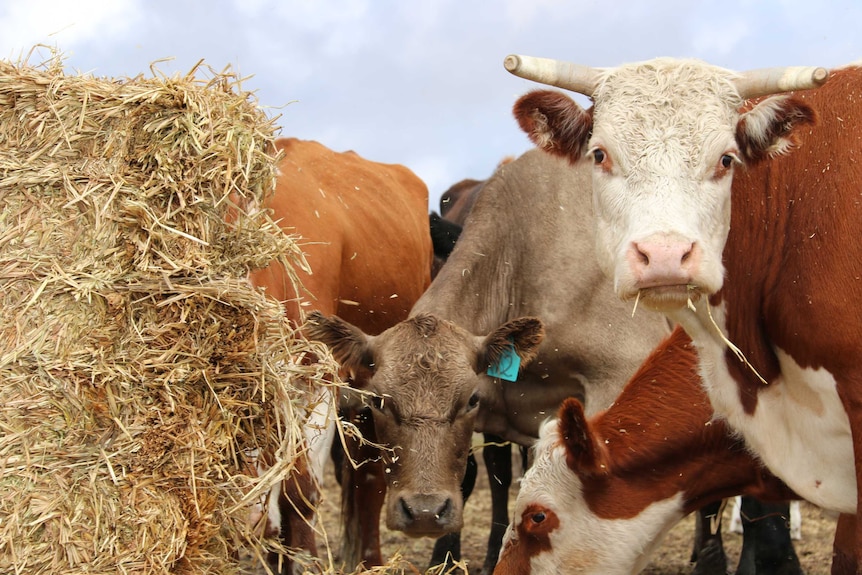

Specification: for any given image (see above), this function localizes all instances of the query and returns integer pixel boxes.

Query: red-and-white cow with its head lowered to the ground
[494,327,799,575]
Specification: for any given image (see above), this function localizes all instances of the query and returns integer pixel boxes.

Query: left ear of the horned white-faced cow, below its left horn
[513,90,593,164]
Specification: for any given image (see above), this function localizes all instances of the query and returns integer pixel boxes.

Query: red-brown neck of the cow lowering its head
[583,331,772,519]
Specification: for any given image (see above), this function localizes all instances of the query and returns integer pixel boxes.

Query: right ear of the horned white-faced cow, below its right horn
[736,95,817,165]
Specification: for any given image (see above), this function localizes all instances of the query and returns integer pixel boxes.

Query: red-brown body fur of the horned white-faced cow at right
[724,67,862,573]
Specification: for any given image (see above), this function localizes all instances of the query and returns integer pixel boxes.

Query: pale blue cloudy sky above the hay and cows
[0,0,862,210]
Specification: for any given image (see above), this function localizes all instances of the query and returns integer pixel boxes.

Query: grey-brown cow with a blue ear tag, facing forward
[308,150,670,567]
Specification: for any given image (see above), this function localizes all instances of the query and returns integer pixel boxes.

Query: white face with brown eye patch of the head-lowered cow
[494,421,683,575]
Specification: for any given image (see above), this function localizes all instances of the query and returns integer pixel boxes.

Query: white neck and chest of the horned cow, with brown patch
[673,280,856,513]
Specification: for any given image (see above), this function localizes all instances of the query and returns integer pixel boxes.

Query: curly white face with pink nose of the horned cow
[587,62,742,309]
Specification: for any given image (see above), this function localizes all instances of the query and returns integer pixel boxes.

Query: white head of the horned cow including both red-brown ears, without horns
[515,59,825,311]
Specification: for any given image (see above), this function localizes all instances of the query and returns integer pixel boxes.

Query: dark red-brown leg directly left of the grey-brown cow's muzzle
[333,407,386,570]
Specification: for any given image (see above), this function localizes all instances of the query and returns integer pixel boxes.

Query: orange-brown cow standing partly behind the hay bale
[250,138,432,572]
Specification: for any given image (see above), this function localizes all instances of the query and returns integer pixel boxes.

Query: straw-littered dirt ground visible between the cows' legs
[312,434,835,575]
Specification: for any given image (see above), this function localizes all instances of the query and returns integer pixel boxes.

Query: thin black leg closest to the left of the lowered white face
[482,434,512,575]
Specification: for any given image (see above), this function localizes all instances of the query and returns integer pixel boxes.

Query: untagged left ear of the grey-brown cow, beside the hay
[305,311,374,380]
